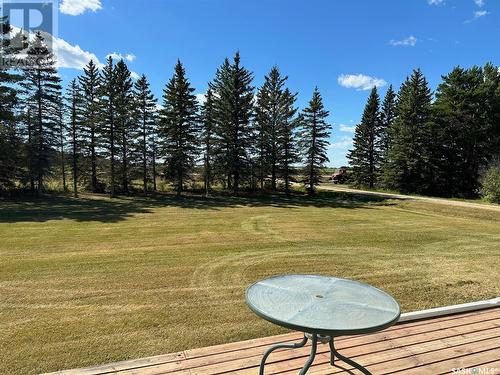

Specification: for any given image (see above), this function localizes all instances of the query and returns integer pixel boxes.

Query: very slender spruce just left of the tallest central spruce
[201,87,216,196]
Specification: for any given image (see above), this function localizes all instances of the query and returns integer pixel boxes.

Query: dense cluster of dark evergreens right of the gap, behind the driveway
[348,64,500,201]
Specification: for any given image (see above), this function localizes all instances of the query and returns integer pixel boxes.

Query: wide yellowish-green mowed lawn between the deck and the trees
[0,192,500,374]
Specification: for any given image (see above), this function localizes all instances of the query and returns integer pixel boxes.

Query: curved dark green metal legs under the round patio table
[259,334,372,375]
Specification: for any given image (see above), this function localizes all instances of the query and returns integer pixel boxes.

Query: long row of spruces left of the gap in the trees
[0,26,330,196]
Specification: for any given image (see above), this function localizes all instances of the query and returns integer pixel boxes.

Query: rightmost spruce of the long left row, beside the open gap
[299,87,331,194]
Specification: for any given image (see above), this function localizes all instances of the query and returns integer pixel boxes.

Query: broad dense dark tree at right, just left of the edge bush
[434,67,491,197]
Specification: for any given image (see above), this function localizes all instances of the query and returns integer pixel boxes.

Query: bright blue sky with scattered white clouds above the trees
[7,0,500,166]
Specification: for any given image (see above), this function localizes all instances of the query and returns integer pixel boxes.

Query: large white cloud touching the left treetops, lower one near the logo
[12,26,102,69]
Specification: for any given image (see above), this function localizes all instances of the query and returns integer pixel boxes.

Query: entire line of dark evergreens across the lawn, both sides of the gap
[0,19,500,197]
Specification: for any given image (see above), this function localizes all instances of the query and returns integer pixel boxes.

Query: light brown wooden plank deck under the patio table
[47,308,500,375]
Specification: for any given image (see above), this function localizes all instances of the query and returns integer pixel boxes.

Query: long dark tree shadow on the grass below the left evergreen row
[0,191,395,223]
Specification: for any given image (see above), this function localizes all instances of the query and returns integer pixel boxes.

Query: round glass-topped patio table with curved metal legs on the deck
[246,275,400,375]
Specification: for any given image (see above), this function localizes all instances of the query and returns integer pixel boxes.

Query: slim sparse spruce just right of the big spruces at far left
[66,79,84,198]
